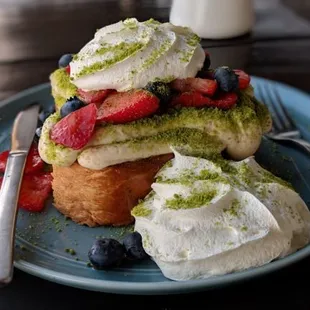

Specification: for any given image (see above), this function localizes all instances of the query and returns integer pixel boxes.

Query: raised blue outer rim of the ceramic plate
[0,75,310,295]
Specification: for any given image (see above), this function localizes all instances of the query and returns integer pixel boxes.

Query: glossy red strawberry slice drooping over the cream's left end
[50,103,97,150]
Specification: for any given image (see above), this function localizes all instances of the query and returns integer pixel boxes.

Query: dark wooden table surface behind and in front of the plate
[0,0,310,310]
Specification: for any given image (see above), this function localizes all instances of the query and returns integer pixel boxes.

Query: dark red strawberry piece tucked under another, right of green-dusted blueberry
[171,91,212,108]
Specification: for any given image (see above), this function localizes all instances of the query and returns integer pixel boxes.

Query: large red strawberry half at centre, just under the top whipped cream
[97,89,159,124]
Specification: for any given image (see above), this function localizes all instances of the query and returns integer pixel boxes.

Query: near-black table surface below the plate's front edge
[0,259,310,310]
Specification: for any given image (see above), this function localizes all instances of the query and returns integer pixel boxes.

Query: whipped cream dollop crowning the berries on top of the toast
[70,18,205,91]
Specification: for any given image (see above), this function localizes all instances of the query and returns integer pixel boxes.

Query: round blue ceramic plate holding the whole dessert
[0,77,310,294]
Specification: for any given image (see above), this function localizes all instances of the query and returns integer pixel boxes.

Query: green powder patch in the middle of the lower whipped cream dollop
[166,189,217,210]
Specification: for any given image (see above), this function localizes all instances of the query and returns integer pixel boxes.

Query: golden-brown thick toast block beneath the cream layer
[52,154,173,227]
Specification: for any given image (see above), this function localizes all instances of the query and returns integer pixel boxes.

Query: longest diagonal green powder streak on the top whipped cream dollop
[76,42,145,77]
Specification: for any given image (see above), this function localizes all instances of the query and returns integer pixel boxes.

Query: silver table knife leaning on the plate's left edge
[0,104,39,285]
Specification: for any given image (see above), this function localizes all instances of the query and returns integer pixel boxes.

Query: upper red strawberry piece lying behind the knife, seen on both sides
[0,143,44,174]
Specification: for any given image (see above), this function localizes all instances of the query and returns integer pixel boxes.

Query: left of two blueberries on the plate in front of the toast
[88,238,125,269]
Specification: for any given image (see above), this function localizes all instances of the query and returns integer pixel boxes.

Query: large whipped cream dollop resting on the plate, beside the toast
[132,151,310,281]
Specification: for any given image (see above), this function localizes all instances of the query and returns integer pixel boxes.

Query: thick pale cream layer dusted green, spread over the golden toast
[39,91,271,170]
